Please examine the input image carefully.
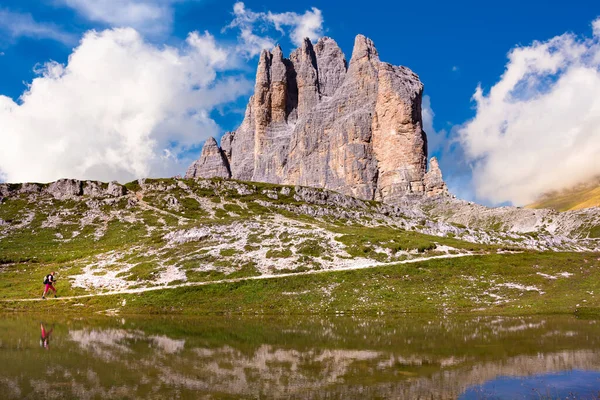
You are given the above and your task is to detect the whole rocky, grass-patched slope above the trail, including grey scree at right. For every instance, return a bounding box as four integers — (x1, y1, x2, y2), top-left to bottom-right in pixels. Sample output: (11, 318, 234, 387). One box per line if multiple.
(0, 178, 600, 295)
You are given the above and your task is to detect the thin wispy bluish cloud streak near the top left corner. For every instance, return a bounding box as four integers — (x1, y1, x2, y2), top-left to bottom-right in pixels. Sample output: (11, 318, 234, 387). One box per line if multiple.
(0, 9, 77, 45)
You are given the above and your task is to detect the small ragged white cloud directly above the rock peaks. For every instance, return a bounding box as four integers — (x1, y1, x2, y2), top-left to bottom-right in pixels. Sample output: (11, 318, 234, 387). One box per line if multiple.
(224, 1, 323, 57)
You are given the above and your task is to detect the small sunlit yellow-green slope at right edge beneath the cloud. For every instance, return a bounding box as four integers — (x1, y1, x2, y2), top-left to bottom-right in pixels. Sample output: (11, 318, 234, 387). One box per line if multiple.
(527, 181, 600, 211)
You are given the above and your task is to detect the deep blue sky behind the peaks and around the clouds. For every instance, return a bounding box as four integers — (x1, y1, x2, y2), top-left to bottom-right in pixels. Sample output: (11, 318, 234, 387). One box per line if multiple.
(0, 0, 600, 204)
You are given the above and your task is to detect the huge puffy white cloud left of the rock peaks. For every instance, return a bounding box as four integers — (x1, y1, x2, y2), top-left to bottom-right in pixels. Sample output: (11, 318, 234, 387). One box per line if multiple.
(0, 28, 252, 182)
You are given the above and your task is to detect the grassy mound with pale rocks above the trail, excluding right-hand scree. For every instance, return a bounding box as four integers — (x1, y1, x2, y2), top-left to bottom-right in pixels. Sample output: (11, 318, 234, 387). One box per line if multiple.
(0, 179, 504, 299)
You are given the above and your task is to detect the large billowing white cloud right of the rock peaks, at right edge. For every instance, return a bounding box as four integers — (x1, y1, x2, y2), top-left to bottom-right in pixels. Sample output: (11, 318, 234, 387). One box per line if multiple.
(458, 19, 600, 205)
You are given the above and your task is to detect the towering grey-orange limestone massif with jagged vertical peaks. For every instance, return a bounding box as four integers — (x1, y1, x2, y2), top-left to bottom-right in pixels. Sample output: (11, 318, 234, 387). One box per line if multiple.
(186, 35, 447, 203)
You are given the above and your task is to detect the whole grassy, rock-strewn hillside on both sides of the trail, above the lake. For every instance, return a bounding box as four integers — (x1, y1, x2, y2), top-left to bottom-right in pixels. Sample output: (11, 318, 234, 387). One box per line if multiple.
(0, 179, 600, 314)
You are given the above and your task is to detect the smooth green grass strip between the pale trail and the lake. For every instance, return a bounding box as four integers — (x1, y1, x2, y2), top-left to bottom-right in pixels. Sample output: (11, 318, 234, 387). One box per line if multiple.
(1, 252, 600, 315)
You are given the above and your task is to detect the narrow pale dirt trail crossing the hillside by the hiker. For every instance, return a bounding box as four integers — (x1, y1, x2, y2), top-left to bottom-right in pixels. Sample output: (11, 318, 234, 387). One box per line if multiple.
(2, 253, 478, 302)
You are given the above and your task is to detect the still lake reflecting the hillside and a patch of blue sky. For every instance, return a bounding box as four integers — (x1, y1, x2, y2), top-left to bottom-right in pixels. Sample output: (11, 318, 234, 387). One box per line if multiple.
(0, 315, 600, 399)
